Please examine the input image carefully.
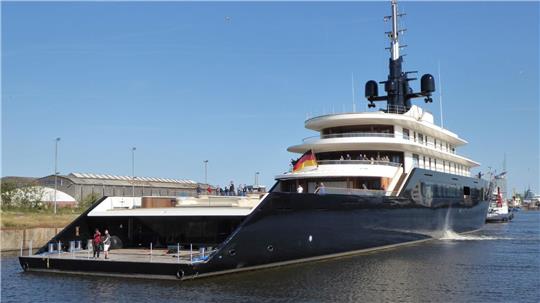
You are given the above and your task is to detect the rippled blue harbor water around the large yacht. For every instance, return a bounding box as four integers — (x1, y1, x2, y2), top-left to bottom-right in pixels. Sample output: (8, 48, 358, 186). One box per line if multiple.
(1, 211, 540, 302)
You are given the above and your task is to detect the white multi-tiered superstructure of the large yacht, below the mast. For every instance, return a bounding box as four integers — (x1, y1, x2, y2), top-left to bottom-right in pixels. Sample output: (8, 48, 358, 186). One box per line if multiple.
(276, 105, 479, 195)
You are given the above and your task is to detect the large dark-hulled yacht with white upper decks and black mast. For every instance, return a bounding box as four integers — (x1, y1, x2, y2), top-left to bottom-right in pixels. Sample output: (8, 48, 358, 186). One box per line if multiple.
(19, 0, 489, 280)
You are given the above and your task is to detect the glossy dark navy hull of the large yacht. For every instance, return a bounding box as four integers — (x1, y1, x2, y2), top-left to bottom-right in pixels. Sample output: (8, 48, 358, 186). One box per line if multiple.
(20, 170, 489, 279)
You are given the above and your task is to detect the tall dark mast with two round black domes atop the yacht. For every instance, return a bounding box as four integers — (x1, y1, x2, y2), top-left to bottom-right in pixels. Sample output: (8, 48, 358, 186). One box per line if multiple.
(365, 0, 435, 114)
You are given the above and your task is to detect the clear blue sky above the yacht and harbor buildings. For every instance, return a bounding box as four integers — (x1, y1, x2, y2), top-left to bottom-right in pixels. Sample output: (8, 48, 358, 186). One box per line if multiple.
(2, 2, 540, 196)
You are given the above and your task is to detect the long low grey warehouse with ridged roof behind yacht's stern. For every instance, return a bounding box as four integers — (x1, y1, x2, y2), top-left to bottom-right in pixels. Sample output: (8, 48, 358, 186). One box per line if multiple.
(37, 173, 198, 201)
